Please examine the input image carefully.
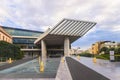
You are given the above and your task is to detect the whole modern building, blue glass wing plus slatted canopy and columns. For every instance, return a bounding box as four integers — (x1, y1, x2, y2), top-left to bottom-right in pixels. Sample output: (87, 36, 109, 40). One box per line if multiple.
(2, 19, 96, 59)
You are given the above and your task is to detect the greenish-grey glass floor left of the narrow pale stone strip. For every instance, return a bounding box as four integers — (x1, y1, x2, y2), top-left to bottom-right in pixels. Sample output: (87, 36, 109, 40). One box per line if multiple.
(0, 58, 60, 80)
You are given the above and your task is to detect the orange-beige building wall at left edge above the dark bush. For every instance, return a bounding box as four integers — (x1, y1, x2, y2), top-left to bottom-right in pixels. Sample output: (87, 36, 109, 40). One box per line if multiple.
(0, 27, 12, 43)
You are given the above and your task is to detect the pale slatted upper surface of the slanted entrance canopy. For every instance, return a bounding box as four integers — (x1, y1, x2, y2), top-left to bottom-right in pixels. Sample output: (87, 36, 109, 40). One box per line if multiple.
(49, 19, 96, 36)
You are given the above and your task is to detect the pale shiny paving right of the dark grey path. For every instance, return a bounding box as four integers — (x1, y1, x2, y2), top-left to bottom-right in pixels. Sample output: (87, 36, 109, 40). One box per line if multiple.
(72, 57, 120, 80)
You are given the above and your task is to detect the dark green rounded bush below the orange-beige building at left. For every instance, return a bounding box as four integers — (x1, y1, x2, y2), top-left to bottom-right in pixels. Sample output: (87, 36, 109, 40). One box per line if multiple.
(0, 41, 24, 60)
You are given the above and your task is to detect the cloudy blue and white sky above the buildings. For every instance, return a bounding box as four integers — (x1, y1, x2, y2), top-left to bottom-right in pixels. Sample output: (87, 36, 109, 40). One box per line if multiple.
(0, 0, 120, 49)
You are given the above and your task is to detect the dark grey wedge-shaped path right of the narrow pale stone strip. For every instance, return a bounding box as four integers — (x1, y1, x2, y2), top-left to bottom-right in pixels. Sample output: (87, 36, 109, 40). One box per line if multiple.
(66, 57, 110, 80)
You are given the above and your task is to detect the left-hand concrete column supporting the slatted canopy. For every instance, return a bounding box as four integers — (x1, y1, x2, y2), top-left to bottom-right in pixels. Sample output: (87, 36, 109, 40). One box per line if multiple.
(41, 40, 47, 62)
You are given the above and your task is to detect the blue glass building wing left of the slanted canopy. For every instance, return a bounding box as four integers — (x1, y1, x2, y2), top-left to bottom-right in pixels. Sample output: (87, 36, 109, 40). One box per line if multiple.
(2, 26, 43, 53)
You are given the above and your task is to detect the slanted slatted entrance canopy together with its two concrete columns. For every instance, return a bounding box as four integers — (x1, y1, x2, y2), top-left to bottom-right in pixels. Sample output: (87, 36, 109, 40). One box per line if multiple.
(34, 19, 96, 61)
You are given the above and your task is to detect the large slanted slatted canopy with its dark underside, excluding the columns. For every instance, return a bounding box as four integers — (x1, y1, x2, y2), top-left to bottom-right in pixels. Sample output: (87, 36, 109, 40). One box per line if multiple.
(34, 19, 96, 45)
